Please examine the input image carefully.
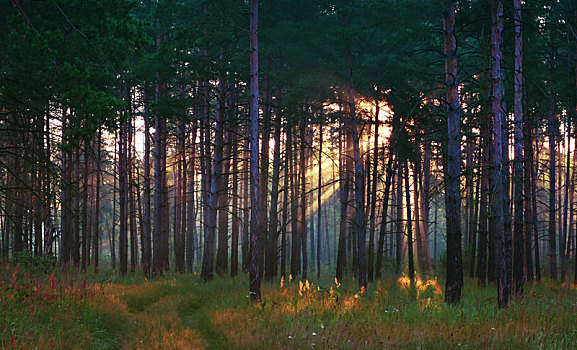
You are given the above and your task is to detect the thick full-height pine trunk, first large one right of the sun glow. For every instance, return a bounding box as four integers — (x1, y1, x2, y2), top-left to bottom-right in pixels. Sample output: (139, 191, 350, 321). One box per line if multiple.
(443, 0, 463, 304)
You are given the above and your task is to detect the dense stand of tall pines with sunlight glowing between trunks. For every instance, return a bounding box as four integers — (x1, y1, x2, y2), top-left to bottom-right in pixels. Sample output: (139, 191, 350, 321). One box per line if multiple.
(0, 0, 577, 306)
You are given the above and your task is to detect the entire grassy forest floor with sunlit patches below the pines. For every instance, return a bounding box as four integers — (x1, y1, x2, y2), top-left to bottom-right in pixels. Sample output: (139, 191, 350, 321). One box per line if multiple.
(0, 263, 577, 349)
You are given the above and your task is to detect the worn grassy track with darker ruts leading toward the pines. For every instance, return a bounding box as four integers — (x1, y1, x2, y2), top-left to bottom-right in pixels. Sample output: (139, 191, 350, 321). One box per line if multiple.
(106, 277, 243, 349)
